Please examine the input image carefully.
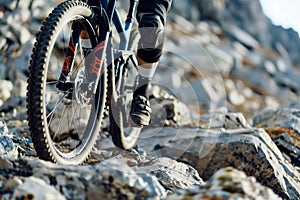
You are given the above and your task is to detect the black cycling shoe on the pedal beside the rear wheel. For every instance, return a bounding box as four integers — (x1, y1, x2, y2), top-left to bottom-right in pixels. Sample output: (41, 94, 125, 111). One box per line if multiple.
(130, 95, 152, 127)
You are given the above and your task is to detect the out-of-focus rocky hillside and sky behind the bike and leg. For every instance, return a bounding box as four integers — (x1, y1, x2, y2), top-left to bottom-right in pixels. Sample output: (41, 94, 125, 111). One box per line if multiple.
(0, 0, 300, 120)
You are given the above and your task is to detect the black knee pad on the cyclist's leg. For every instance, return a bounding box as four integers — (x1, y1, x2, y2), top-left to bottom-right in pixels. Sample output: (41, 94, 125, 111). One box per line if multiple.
(138, 13, 164, 63)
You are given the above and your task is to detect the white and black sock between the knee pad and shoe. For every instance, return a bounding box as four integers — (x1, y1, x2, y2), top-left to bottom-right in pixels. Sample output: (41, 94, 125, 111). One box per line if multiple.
(133, 62, 158, 98)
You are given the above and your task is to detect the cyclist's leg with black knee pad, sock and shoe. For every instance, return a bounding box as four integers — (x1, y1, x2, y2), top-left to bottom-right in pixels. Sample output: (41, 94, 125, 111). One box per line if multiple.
(131, 0, 172, 126)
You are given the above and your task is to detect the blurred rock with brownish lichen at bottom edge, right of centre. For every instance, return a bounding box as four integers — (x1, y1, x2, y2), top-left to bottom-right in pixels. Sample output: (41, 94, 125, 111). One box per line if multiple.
(167, 167, 281, 200)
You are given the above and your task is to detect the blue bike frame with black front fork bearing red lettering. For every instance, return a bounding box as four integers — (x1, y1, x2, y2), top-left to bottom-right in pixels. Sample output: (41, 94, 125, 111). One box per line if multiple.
(57, 0, 139, 94)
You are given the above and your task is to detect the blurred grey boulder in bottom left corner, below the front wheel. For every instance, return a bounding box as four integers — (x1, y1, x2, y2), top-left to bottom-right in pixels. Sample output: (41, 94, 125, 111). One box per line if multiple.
(0, 160, 166, 199)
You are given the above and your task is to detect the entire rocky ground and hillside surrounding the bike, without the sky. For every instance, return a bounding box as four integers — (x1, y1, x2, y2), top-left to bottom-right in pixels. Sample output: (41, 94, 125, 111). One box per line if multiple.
(0, 0, 300, 200)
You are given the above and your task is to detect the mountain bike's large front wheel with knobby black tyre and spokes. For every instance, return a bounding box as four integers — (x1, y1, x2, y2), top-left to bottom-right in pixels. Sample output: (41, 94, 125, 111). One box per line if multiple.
(27, 1, 107, 165)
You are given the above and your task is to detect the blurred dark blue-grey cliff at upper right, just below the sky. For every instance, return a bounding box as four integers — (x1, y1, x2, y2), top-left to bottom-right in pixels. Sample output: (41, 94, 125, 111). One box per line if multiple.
(190, 0, 300, 65)
